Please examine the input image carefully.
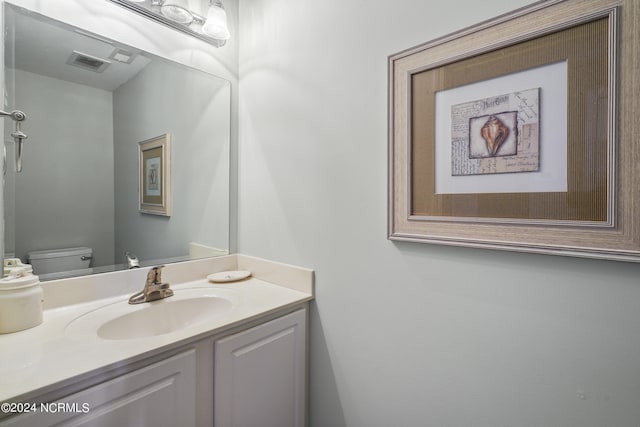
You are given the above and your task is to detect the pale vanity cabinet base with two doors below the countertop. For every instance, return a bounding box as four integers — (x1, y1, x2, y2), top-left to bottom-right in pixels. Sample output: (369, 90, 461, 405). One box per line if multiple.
(0, 305, 307, 427)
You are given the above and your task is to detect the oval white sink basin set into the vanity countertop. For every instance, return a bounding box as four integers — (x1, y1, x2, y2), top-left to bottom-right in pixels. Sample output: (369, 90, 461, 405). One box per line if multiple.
(66, 288, 235, 340)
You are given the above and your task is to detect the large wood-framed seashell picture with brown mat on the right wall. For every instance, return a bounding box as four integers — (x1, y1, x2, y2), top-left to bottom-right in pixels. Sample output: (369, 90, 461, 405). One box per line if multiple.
(388, 0, 640, 261)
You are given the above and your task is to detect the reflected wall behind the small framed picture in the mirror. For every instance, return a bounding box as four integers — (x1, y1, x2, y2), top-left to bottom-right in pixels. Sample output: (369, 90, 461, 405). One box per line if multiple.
(114, 60, 231, 260)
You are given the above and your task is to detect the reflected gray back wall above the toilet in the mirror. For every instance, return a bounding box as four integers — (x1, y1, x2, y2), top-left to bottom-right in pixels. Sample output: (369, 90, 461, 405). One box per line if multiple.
(5, 70, 114, 265)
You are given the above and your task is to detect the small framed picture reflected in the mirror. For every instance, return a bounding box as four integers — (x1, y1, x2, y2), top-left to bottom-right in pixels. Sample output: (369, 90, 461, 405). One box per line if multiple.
(138, 134, 171, 216)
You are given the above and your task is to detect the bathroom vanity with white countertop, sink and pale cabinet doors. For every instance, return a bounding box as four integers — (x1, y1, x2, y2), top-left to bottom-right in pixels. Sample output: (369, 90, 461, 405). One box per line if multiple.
(0, 255, 313, 427)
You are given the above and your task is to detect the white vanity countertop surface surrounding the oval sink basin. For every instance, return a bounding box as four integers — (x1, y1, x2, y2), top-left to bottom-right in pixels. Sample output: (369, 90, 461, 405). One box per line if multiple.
(0, 255, 313, 402)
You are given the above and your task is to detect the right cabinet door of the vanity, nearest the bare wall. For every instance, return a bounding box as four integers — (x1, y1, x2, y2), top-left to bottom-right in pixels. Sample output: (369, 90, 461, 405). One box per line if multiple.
(214, 309, 306, 427)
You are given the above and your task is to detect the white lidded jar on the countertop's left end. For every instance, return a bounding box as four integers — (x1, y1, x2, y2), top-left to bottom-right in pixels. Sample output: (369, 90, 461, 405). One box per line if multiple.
(0, 258, 43, 334)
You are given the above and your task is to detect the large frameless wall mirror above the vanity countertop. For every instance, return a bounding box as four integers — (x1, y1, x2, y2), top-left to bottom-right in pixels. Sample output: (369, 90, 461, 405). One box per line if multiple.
(3, 3, 231, 279)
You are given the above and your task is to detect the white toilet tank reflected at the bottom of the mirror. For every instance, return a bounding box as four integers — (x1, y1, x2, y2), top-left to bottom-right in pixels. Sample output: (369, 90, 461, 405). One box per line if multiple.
(27, 247, 93, 275)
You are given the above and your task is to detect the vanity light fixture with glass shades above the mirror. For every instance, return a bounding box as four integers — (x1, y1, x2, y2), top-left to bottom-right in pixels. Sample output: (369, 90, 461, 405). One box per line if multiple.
(110, 0, 231, 47)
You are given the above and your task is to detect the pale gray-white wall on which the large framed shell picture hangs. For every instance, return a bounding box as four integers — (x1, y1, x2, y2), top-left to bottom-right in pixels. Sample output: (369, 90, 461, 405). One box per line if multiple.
(239, 0, 640, 427)
